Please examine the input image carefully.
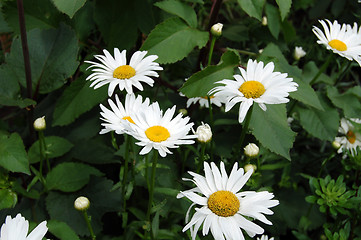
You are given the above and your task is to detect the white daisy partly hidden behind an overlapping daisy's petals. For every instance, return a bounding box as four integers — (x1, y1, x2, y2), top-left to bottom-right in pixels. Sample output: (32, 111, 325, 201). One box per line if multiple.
(100, 94, 149, 134)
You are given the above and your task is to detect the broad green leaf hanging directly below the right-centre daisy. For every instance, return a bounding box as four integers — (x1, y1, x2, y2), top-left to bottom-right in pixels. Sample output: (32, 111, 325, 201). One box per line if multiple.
(250, 104, 296, 160)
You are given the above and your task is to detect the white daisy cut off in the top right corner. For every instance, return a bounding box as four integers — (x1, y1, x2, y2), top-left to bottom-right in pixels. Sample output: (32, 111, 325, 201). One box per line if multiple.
(312, 19, 361, 66)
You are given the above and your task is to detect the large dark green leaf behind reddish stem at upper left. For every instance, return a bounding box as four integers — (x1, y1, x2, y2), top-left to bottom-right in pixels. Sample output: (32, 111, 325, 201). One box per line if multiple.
(6, 24, 79, 93)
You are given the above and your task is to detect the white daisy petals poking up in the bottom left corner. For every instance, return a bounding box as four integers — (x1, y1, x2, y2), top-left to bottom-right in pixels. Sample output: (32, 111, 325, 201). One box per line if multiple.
(0, 213, 48, 240)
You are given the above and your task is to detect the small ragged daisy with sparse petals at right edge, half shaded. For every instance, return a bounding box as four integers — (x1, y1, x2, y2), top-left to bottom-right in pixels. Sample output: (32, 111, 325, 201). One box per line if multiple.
(335, 118, 361, 156)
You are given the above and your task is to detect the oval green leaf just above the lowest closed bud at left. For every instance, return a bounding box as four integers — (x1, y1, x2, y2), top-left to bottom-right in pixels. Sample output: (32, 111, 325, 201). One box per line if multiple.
(46, 162, 103, 192)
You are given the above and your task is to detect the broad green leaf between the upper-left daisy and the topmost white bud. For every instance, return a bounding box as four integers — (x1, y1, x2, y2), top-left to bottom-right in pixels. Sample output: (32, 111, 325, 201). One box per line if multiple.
(141, 18, 209, 63)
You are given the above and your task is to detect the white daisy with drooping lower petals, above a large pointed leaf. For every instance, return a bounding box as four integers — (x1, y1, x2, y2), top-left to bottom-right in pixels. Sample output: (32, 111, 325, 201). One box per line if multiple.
(209, 59, 298, 123)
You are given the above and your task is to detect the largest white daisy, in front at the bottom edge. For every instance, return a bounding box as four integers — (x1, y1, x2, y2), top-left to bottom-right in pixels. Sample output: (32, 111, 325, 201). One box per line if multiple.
(177, 162, 279, 240)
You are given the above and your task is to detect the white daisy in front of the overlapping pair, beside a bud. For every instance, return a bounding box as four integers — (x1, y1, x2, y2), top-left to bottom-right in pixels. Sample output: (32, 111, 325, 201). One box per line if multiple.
(121, 102, 197, 157)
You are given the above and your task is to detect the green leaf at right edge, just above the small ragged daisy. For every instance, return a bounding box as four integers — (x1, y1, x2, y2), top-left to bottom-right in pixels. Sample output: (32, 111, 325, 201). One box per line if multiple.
(327, 86, 361, 118)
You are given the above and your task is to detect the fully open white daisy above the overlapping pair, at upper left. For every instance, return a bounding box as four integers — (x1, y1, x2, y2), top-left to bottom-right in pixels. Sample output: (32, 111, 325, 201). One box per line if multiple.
(85, 48, 163, 96)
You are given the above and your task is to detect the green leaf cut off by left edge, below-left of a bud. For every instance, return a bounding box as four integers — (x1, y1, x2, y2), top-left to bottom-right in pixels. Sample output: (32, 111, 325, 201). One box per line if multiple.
(0, 133, 30, 175)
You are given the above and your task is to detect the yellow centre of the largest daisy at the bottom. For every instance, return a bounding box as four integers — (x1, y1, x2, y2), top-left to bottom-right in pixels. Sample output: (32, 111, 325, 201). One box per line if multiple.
(207, 191, 240, 217)
